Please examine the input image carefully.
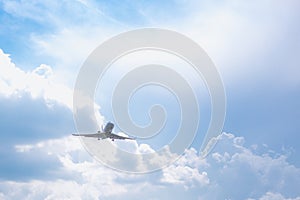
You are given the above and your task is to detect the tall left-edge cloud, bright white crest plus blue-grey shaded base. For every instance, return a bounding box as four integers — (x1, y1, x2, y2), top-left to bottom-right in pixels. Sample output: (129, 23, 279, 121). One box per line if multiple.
(0, 49, 74, 180)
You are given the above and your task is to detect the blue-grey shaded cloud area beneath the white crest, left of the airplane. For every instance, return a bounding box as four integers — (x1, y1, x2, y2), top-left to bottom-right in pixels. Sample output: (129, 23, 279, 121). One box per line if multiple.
(0, 94, 74, 180)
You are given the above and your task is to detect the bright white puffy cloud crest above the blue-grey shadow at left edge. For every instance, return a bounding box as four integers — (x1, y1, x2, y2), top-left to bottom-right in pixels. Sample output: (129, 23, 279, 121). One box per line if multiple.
(0, 49, 73, 109)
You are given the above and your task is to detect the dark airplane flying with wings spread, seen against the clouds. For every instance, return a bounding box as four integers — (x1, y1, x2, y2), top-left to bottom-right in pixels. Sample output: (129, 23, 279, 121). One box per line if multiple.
(72, 122, 135, 141)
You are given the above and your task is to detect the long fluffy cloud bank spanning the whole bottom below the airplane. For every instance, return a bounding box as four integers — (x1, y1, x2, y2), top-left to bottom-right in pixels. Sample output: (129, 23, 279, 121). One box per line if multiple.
(0, 133, 300, 199)
